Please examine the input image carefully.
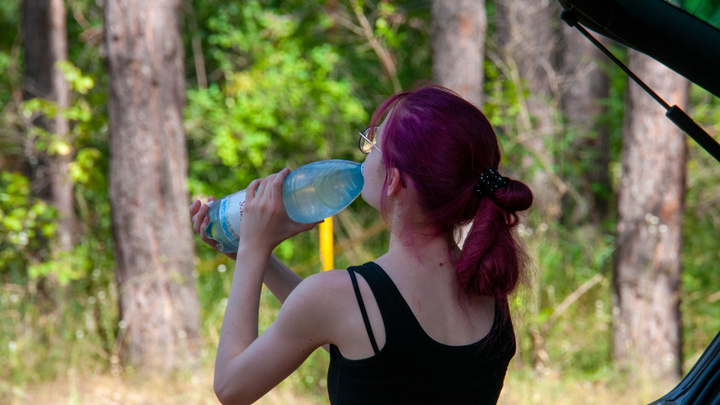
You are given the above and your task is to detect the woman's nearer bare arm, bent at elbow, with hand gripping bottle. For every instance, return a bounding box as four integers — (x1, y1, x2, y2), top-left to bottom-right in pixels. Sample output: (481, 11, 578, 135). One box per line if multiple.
(210, 170, 334, 404)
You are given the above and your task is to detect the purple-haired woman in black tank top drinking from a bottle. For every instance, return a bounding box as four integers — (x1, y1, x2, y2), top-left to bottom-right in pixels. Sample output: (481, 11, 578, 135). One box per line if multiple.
(190, 86, 532, 404)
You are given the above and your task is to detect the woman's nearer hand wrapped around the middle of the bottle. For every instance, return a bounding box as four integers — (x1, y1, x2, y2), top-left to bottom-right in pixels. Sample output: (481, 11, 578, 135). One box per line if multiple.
(240, 169, 322, 254)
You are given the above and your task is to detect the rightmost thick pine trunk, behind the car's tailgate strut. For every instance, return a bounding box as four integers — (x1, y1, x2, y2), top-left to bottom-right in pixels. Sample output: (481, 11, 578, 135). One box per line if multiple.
(613, 50, 689, 380)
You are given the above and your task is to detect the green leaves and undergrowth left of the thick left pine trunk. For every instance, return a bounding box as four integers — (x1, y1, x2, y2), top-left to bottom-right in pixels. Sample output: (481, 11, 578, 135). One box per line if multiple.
(0, 0, 117, 392)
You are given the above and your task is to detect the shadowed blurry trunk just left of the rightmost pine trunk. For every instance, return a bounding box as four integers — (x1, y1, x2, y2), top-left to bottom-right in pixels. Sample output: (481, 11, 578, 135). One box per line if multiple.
(561, 24, 612, 225)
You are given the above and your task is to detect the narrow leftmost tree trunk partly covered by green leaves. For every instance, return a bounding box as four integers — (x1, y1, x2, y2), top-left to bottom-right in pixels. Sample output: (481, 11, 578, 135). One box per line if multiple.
(23, 0, 76, 251)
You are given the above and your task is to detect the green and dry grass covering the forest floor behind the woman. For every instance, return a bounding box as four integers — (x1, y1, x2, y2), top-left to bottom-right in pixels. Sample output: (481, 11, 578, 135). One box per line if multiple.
(0, 202, 720, 405)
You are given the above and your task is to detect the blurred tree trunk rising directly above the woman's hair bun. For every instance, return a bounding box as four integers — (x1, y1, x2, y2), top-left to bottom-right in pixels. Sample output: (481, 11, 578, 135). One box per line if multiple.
(495, 0, 567, 220)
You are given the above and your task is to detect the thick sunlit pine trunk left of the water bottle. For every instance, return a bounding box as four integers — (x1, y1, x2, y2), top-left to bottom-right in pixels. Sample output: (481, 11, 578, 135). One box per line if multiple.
(105, 0, 200, 371)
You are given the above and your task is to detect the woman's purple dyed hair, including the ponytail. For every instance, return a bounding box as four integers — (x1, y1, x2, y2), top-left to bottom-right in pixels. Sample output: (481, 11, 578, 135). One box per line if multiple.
(371, 85, 533, 299)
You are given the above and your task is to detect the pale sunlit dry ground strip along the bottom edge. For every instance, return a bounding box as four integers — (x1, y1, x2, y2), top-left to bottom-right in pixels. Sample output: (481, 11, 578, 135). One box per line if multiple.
(0, 370, 672, 405)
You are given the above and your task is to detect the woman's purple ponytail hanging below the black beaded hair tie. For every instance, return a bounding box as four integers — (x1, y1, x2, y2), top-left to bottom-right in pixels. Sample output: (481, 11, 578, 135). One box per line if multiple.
(456, 180, 533, 298)
